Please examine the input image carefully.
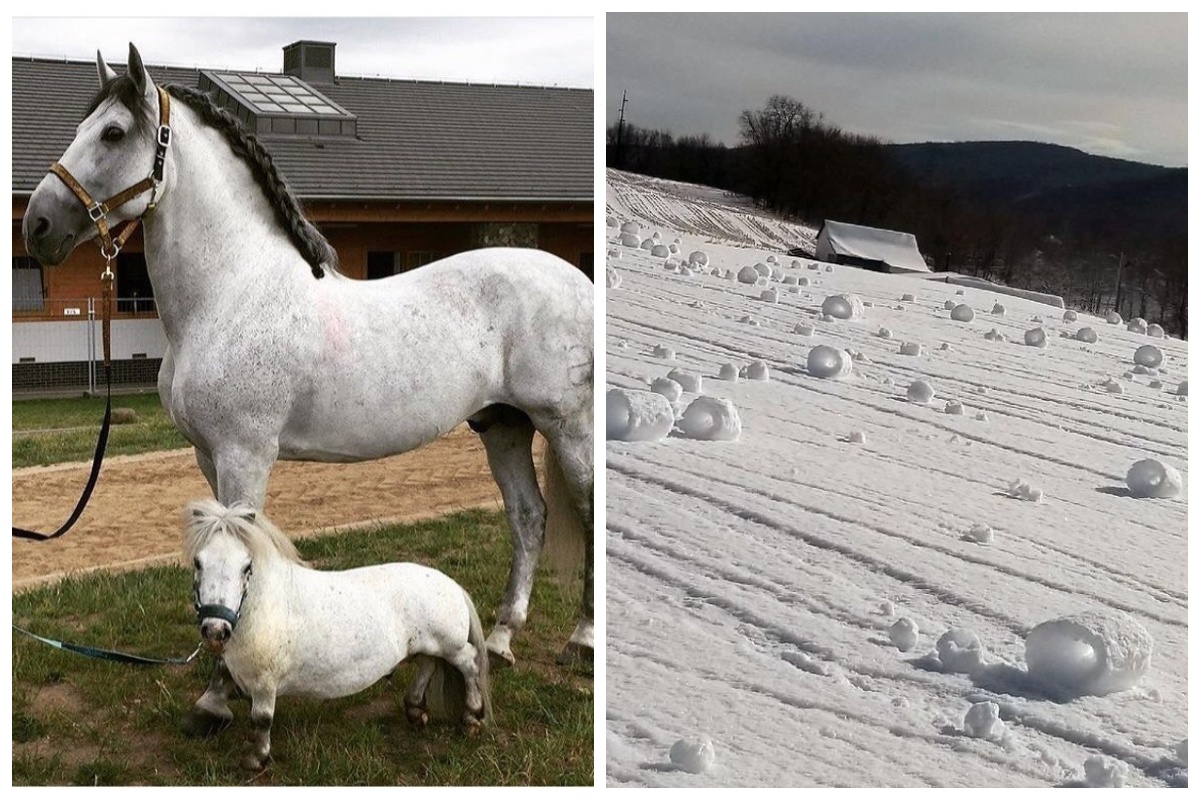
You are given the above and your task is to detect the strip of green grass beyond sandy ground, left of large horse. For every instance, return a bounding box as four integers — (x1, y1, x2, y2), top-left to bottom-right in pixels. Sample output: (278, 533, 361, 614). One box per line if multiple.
(12, 392, 187, 469)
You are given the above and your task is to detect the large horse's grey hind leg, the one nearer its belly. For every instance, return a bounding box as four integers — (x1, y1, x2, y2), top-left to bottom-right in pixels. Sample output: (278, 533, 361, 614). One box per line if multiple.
(470, 405, 546, 667)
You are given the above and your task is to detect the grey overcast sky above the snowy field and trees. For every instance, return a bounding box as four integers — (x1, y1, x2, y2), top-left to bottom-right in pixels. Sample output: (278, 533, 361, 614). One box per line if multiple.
(605, 13, 1188, 167)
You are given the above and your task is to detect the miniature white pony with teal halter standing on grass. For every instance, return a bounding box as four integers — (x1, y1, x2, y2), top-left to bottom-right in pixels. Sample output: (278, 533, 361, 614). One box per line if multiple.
(184, 500, 492, 770)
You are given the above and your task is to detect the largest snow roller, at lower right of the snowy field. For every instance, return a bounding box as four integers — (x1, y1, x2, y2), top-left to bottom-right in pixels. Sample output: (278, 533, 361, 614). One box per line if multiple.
(1025, 612, 1154, 694)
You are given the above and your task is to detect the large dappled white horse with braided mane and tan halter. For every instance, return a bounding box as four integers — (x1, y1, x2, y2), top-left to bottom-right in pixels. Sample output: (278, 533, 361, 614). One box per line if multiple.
(23, 44, 594, 734)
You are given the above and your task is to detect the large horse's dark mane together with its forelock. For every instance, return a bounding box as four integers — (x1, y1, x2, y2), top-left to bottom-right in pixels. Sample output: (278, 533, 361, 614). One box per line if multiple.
(84, 74, 337, 278)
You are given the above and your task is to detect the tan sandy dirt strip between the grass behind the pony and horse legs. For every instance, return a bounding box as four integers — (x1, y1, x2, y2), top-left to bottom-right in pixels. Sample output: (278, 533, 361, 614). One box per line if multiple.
(12, 426, 500, 591)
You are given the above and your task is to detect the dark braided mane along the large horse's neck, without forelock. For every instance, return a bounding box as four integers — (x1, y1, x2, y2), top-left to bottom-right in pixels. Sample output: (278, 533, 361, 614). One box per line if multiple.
(166, 84, 337, 278)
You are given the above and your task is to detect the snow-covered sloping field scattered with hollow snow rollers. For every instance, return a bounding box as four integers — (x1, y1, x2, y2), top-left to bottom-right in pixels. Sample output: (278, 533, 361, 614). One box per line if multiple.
(606, 172, 1188, 787)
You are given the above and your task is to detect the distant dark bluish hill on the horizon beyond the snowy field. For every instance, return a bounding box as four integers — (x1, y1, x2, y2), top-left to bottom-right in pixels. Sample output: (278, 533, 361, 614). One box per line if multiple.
(884, 142, 1188, 244)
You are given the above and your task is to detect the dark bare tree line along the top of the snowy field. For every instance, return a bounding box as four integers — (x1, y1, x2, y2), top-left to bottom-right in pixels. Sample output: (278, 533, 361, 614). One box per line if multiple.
(606, 95, 1187, 337)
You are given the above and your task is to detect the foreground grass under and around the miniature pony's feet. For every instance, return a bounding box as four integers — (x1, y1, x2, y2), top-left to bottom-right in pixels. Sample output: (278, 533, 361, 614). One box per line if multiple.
(12, 511, 594, 786)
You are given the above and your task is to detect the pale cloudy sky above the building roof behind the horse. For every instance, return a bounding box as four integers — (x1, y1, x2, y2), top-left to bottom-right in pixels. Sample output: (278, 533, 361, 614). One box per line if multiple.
(12, 15, 595, 89)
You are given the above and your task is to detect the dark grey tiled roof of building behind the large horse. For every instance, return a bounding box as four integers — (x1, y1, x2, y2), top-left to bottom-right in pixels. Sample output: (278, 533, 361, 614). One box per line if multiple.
(12, 58, 594, 203)
